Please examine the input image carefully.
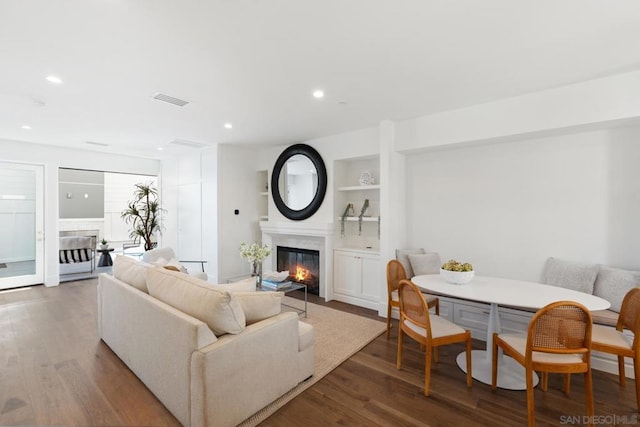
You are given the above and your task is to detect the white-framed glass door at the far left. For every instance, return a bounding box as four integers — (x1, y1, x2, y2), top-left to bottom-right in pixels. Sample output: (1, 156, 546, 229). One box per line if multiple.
(0, 162, 44, 289)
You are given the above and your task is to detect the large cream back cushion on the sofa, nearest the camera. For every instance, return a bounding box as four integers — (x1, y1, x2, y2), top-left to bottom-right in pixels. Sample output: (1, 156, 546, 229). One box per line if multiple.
(147, 268, 246, 335)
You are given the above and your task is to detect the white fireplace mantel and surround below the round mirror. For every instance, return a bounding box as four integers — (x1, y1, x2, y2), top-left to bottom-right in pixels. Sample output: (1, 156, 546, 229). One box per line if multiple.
(260, 221, 334, 301)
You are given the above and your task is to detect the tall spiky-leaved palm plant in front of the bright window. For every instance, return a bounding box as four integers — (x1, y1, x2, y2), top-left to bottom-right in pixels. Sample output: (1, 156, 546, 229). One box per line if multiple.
(120, 183, 164, 251)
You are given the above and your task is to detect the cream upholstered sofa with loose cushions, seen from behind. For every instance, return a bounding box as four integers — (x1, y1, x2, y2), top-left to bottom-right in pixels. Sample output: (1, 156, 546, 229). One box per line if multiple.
(98, 257, 314, 426)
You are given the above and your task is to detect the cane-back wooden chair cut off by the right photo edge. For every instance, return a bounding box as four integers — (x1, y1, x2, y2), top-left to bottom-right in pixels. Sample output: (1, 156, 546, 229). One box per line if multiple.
(591, 288, 640, 412)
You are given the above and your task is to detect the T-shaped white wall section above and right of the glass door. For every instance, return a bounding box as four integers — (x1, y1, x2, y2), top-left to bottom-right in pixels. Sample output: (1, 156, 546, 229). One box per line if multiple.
(0, 140, 160, 286)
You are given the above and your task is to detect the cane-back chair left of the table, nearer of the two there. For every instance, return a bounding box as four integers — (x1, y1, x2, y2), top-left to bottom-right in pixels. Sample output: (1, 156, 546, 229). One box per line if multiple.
(397, 280, 473, 396)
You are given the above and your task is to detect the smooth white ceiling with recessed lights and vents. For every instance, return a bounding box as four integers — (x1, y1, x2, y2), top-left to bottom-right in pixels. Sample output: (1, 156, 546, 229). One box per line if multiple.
(0, 0, 640, 158)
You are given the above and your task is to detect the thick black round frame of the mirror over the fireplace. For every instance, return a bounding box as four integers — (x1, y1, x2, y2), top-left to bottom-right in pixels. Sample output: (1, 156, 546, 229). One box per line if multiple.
(271, 144, 327, 221)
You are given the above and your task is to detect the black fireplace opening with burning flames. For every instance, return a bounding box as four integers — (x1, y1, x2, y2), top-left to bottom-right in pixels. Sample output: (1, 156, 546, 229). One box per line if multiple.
(276, 246, 320, 295)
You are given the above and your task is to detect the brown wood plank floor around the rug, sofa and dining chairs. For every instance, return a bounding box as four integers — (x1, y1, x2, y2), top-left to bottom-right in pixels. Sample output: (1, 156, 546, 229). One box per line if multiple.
(0, 279, 636, 426)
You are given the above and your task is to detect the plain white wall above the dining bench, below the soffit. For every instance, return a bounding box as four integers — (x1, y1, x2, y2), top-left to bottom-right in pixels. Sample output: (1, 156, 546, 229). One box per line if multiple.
(406, 127, 640, 281)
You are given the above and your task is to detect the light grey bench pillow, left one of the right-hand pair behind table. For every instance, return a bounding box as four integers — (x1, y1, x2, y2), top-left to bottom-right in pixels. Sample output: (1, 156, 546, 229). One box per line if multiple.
(544, 257, 600, 294)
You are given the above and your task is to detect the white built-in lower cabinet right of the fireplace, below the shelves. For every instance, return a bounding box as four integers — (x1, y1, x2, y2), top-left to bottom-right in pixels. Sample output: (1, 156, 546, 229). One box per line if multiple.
(333, 249, 381, 310)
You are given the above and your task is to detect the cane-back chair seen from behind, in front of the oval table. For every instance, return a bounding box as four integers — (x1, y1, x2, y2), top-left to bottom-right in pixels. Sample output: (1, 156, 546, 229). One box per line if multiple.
(491, 301, 593, 426)
